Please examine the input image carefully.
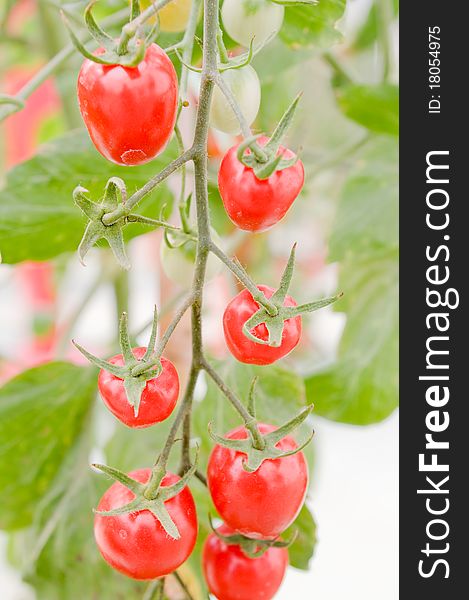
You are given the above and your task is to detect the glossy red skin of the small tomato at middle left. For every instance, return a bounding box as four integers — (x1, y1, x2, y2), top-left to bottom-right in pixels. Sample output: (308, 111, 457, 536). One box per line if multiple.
(98, 348, 179, 428)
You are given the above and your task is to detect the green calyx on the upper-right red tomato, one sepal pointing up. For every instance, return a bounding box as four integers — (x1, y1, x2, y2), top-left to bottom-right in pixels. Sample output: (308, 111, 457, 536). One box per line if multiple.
(237, 93, 302, 180)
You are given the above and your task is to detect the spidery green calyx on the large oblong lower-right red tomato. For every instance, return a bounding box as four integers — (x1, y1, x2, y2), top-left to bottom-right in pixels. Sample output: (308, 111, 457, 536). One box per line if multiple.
(208, 377, 314, 473)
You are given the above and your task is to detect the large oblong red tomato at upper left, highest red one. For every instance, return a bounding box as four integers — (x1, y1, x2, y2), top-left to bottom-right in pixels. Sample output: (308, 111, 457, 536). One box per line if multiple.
(78, 44, 178, 166)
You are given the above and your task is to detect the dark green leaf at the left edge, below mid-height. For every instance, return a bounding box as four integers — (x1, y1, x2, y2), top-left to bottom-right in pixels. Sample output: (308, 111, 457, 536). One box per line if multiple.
(0, 362, 96, 530)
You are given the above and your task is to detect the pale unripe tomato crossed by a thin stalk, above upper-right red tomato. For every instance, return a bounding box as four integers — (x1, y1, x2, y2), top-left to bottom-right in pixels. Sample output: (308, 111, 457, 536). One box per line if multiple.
(210, 65, 261, 135)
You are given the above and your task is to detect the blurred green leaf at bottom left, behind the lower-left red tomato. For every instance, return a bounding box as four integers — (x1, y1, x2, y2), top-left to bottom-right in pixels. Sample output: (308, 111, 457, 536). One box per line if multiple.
(9, 468, 148, 600)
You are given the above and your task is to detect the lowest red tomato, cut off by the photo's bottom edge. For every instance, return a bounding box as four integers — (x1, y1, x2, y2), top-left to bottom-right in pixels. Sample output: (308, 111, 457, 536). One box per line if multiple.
(202, 525, 288, 600)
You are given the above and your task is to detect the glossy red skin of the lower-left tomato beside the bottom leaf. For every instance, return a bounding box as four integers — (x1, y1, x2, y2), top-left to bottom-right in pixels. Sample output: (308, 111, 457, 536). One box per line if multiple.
(94, 469, 197, 579)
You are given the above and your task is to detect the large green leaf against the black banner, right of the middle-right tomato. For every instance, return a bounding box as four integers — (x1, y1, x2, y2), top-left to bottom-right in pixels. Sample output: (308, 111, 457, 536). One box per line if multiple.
(306, 250, 399, 425)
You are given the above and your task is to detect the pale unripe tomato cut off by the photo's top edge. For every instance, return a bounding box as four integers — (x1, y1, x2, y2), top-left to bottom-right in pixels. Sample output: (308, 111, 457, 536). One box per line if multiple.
(221, 0, 285, 48)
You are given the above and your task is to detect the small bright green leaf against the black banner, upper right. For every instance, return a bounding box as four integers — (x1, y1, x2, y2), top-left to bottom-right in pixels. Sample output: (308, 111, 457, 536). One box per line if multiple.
(336, 83, 399, 136)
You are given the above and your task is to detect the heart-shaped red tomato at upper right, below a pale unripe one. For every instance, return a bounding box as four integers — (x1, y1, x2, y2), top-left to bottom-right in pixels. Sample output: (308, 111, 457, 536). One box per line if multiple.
(218, 137, 305, 231)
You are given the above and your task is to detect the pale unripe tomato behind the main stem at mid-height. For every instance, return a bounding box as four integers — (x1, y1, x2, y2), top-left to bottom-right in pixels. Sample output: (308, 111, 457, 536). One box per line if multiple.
(160, 231, 222, 288)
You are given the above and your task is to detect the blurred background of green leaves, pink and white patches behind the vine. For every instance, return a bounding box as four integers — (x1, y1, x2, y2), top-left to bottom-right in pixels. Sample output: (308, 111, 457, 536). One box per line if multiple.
(0, 0, 398, 600)
